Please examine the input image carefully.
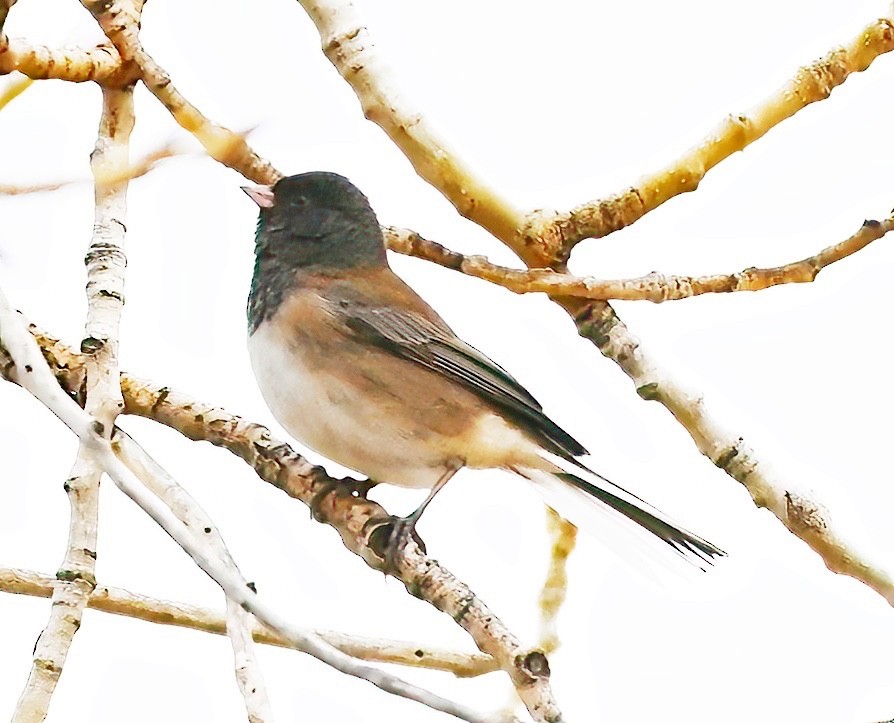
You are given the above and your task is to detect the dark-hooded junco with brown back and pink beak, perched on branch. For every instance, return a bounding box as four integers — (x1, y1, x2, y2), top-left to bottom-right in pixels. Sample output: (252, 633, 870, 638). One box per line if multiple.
(244, 173, 725, 562)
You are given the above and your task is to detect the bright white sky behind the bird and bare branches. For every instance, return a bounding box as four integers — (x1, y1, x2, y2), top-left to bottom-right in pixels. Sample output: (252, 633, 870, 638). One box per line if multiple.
(0, 0, 894, 723)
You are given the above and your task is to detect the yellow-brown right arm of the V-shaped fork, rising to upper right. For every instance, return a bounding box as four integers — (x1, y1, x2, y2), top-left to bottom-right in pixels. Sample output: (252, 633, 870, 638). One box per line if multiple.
(522, 18, 894, 261)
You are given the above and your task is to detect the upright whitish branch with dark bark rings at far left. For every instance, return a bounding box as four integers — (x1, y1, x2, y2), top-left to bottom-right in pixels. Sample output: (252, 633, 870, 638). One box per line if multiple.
(13, 82, 134, 723)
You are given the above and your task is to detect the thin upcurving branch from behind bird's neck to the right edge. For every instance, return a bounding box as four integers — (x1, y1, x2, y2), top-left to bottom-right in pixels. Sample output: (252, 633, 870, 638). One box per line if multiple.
(383, 216, 894, 304)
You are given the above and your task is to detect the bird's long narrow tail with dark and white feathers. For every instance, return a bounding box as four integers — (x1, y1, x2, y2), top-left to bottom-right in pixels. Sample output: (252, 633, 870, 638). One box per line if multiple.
(514, 455, 726, 569)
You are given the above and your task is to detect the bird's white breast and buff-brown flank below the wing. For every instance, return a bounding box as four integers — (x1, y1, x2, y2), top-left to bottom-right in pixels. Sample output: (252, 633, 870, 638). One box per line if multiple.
(248, 296, 458, 487)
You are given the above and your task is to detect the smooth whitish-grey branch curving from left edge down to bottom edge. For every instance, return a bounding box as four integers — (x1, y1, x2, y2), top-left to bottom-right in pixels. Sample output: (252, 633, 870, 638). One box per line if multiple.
(0, 302, 508, 723)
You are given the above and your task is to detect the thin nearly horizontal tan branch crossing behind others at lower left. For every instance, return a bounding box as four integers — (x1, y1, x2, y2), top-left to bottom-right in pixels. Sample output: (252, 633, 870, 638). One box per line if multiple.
(0, 568, 500, 678)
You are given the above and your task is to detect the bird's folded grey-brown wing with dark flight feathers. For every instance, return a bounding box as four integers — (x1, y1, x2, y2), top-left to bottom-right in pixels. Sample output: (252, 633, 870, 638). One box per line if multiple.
(325, 273, 587, 458)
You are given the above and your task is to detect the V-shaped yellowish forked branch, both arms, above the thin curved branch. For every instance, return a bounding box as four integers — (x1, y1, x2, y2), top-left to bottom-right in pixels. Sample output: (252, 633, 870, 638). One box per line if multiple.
(299, 0, 894, 267)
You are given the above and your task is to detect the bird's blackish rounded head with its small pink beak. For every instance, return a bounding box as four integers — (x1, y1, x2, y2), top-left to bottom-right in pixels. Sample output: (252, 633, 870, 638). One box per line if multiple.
(243, 172, 386, 273)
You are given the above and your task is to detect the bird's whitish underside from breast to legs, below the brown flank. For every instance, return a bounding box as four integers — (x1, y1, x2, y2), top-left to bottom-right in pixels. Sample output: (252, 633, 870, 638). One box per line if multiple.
(248, 322, 446, 487)
